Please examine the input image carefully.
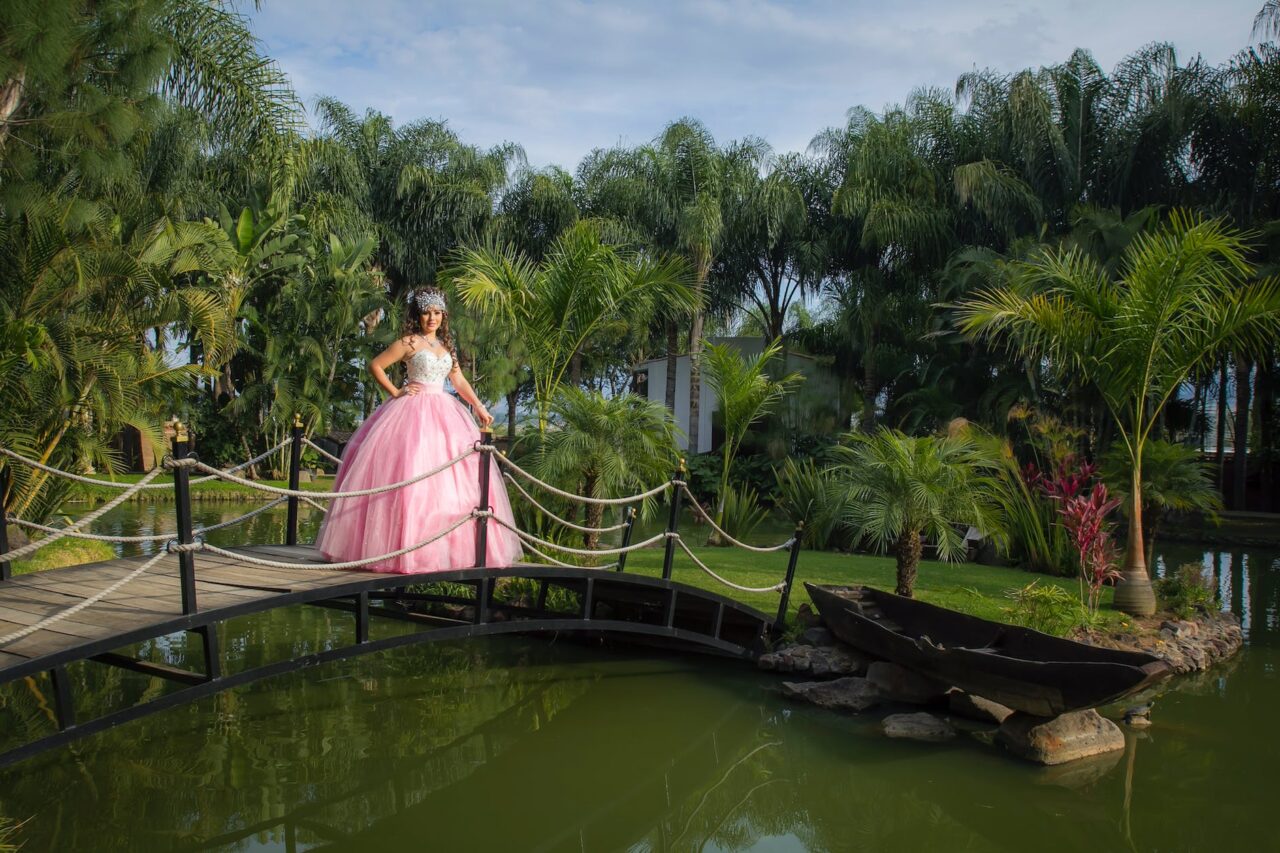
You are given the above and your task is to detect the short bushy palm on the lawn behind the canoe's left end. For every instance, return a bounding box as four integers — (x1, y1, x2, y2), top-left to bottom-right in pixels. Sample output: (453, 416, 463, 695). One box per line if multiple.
(835, 428, 1002, 598)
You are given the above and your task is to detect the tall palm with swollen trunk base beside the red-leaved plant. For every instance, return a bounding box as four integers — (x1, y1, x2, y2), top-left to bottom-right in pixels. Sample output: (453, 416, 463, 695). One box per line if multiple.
(956, 213, 1280, 615)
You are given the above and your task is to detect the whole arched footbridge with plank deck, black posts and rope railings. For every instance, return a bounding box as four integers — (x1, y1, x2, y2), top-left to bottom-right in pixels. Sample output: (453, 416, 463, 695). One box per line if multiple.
(0, 424, 799, 765)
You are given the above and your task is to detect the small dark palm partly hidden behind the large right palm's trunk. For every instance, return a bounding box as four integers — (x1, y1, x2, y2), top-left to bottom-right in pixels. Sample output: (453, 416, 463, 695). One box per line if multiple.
(1102, 441, 1222, 566)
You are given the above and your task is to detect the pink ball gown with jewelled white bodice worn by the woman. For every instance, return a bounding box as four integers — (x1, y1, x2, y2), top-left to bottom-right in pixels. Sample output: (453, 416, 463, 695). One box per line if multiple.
(316, 350, 521, 574)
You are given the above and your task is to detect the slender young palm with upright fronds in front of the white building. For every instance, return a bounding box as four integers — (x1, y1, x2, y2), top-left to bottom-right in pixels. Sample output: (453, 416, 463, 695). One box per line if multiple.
(707, 341, 804, 526)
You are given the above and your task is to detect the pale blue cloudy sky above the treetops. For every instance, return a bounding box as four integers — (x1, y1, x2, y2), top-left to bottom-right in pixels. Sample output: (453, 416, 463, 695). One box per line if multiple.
(248, 0, 1262, 169)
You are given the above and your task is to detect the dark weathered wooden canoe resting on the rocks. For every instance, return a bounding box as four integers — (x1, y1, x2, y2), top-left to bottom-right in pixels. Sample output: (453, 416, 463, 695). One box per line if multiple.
(805, 584, 1171, 717)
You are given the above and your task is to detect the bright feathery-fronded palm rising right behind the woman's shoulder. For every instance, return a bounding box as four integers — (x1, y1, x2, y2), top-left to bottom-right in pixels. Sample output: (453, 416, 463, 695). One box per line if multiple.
(443, 220, 696, 433)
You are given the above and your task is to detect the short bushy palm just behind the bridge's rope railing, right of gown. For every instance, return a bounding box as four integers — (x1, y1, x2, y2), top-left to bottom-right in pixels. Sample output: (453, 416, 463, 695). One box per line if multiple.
(534, 387, 677, 548)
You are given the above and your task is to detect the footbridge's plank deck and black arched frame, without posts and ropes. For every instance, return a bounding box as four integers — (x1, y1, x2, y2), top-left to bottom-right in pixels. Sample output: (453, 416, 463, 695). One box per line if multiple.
(0, 546, 773, 766)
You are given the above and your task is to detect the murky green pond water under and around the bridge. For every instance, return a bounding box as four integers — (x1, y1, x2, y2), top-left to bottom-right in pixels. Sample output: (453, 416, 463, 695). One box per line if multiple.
(0, 503, 1280, 853)
